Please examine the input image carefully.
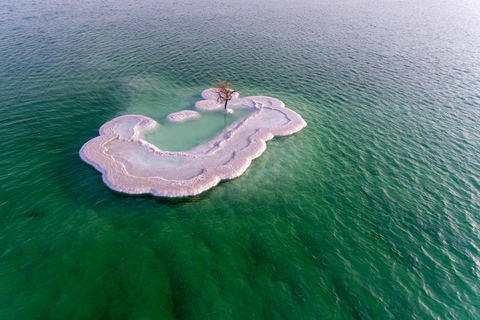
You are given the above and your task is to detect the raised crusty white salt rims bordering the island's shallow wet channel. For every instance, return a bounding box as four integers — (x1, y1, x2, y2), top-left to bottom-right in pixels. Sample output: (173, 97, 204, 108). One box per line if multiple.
(79, 89, 307, 197)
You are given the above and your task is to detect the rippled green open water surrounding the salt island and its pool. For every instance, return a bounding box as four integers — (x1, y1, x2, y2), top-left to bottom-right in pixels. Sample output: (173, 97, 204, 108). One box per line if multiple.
(0, 0, 480, 320)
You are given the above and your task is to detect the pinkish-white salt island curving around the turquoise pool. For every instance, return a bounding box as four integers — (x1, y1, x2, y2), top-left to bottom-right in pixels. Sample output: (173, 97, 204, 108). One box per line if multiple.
(80, 89, 307, 197)
